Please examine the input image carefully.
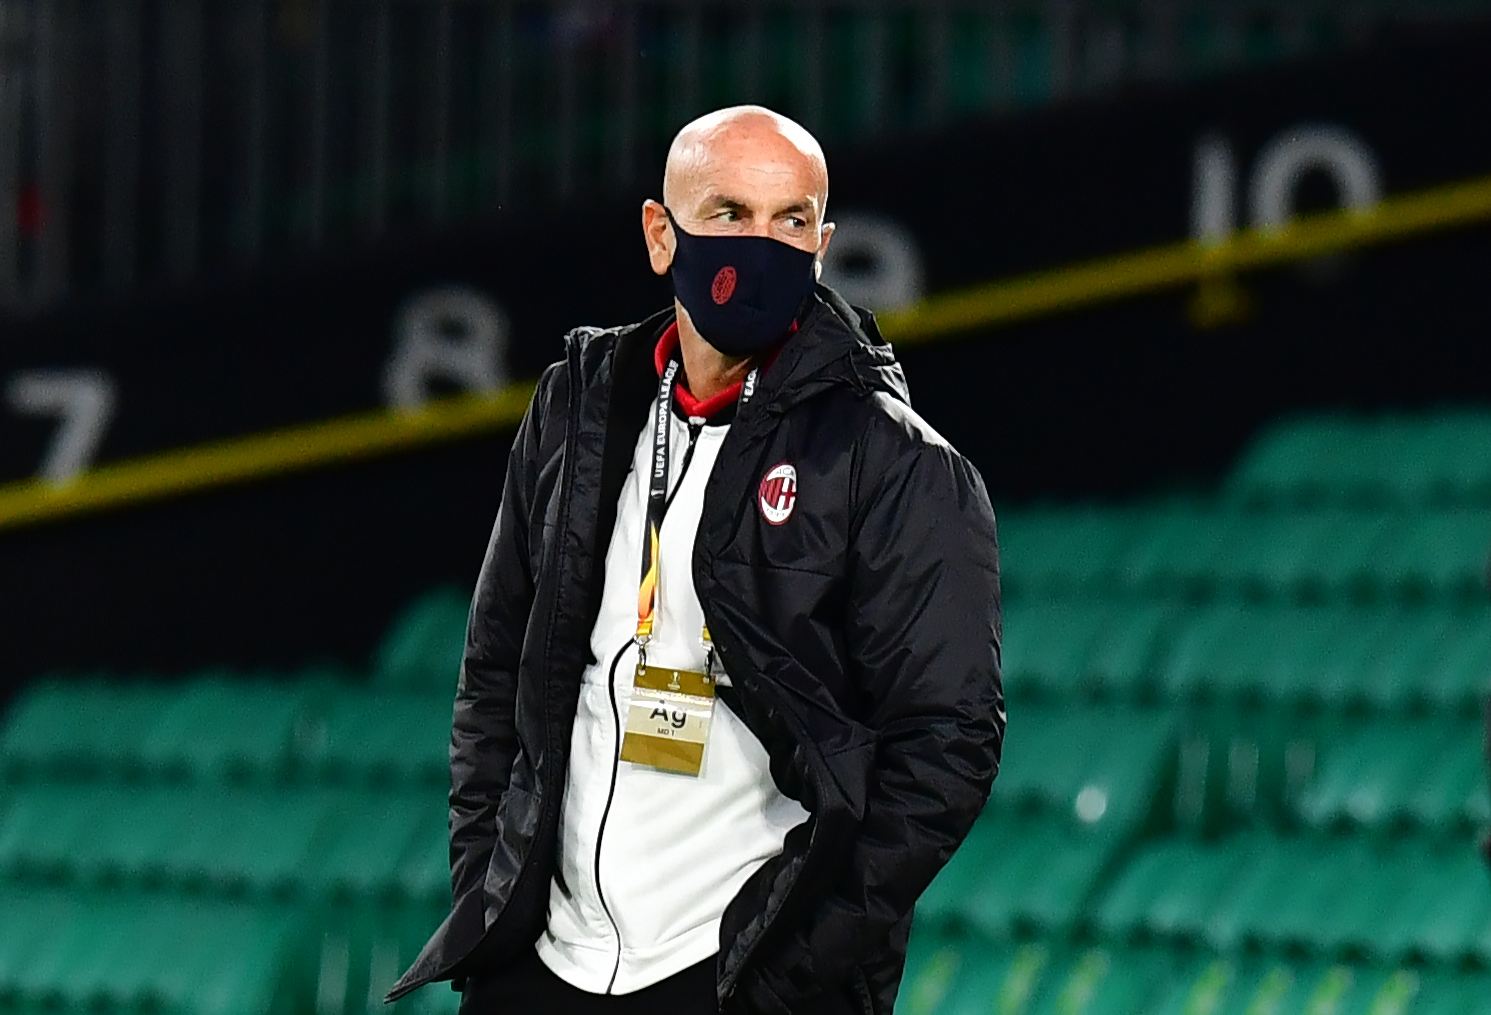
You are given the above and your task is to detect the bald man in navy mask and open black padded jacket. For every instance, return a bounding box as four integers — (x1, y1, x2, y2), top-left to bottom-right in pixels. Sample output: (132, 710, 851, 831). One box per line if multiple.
(389, 107, 1005, 1015)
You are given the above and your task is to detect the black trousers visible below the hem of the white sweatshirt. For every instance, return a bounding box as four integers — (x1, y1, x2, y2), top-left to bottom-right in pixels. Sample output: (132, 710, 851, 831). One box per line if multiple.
(461, 949, 720, 1015)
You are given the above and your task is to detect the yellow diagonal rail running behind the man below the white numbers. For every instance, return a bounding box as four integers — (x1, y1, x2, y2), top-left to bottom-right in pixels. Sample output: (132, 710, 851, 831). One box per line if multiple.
(0, 166, 1491, 529)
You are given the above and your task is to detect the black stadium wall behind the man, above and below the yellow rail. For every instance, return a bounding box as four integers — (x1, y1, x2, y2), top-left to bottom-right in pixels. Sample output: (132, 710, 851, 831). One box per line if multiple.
(0, 21, 1491, 686)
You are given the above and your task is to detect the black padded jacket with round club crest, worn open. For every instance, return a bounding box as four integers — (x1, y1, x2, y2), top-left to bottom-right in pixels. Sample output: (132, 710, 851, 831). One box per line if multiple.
(389, 286, 1005, 1015)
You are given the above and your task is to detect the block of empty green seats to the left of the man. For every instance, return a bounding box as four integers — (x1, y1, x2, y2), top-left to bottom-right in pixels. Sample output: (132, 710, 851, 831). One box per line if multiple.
(0, 611, 464, 1015)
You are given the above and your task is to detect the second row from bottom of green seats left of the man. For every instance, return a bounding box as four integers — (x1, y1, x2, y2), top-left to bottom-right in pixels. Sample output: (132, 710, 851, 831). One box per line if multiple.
(0, 784, 465, 905)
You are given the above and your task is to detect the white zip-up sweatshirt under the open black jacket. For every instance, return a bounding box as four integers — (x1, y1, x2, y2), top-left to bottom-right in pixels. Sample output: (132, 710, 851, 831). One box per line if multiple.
(538, 390, 807, 994)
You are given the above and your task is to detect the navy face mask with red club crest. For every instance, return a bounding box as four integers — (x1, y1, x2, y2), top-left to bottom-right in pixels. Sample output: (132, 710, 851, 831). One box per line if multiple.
(663, 209, 817, 356)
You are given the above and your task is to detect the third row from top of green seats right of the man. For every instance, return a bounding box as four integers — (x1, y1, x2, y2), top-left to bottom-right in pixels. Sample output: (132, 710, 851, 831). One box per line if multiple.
(1003, 598, 1491, 715)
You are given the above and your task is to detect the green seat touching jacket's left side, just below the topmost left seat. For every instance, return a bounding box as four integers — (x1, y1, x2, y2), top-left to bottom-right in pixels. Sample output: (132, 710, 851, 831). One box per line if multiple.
(301, 687, 453, 785)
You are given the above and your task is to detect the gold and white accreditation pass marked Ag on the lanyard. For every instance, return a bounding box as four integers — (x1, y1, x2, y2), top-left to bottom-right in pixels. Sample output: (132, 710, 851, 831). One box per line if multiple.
(622, 666, 714, 775)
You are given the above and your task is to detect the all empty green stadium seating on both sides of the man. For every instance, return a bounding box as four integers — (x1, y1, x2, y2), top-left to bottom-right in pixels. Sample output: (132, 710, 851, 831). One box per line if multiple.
(0, 414, 1491, 1015)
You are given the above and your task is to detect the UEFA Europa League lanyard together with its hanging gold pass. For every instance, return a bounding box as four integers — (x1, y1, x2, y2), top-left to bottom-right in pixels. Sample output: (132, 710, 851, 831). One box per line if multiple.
(622, 359, 759, 775)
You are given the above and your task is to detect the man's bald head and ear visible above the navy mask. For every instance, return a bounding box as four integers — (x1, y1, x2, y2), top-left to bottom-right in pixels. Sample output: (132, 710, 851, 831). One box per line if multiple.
(643, 106, 833, 274)
